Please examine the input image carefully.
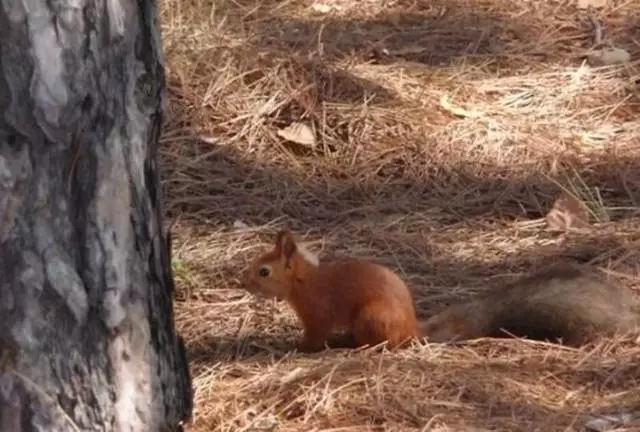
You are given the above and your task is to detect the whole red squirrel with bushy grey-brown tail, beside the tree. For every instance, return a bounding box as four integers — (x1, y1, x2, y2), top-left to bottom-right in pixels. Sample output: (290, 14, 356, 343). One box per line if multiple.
(245, 231, 640, 352)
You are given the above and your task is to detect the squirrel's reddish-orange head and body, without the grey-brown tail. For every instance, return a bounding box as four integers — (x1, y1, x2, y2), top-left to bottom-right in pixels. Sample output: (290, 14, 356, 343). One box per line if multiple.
(246, 231, 419, 351)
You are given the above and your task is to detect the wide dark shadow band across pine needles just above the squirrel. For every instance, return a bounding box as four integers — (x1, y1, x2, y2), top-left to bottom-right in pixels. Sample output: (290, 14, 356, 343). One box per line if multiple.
(164, 139, 640, 231)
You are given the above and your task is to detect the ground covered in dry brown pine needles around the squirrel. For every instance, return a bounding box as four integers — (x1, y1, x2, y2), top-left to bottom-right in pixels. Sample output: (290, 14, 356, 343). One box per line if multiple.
(160, 0, 640, 431)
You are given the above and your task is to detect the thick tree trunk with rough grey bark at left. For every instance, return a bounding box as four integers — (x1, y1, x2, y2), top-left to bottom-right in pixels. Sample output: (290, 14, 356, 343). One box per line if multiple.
(0, 0, 191, 432)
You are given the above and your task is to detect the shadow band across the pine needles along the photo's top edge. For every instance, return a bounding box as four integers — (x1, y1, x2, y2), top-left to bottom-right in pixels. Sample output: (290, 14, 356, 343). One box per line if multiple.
(208, 0, 640, 69)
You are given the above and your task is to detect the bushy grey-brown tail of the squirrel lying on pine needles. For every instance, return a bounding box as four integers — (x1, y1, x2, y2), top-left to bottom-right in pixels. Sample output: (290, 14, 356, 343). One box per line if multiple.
(421, 265, 640, 345)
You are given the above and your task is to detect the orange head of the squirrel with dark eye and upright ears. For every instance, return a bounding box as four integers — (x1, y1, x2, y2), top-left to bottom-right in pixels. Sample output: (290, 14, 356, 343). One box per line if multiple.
(245, 230, 318, 300)
